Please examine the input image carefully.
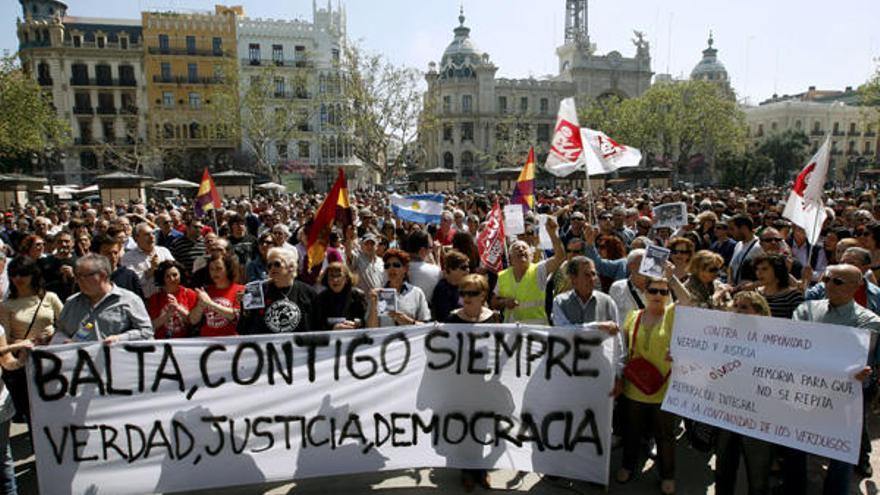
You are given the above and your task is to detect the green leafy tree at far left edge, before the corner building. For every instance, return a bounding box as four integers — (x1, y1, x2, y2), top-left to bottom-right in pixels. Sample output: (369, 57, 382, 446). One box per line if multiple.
(0, 56, 70, 165)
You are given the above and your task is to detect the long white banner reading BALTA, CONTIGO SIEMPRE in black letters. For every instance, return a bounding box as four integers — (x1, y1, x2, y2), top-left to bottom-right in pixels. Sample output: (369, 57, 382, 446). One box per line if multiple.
(28, 324, 617, 495)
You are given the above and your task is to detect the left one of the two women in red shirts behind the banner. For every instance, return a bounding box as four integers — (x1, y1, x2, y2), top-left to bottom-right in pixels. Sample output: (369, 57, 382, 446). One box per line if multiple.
(147, 260, 199, 339)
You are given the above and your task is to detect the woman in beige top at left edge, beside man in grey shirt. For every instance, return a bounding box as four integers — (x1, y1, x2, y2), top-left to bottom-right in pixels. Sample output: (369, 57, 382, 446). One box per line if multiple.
(0, 256, 64, 422)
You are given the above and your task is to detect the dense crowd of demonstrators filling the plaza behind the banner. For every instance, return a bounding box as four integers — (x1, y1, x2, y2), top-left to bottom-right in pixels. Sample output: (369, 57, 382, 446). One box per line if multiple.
(0, 184, 880, 495)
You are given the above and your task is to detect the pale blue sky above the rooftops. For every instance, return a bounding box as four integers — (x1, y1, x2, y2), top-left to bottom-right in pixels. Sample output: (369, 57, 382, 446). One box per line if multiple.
(0, 0, 880, 103)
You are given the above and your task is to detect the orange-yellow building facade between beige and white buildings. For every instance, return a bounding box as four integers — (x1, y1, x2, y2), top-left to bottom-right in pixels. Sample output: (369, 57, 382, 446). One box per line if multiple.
(141, 5, 244, 177)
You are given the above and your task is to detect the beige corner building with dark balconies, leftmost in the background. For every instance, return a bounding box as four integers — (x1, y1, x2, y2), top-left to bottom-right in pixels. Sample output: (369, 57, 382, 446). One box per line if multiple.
(17, 0, 153, 184)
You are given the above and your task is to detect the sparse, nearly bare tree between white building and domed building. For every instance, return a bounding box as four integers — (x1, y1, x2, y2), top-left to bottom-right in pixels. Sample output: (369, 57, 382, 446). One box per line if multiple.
(342, 44, 433, 178)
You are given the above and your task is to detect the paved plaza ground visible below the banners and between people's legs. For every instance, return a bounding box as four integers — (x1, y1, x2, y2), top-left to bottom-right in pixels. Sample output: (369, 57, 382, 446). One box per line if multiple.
(12, 415, 880, 495)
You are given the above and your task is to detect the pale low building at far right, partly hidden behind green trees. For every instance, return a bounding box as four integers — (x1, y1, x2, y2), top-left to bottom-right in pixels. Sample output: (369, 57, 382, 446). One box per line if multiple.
(744, 86, 880, 181)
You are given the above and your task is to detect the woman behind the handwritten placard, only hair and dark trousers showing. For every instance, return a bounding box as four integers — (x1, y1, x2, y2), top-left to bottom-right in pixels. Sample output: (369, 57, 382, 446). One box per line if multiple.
(715, 291, 773, 495)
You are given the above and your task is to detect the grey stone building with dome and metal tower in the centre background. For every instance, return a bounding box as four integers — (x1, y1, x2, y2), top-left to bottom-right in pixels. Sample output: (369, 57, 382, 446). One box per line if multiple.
(419, 0, 652, 185)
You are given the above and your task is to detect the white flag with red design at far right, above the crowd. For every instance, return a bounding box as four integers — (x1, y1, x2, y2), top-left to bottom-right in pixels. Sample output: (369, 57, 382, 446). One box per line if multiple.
(782, 136, 831, 244)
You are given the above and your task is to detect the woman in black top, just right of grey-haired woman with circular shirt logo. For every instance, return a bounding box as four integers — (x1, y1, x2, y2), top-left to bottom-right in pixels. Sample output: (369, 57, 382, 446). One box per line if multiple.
(315, 262, 367, 330)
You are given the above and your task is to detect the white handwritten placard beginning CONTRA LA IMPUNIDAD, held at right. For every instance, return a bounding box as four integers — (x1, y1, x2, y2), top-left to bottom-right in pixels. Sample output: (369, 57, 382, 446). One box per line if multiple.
(663, 307, 869, 464)
